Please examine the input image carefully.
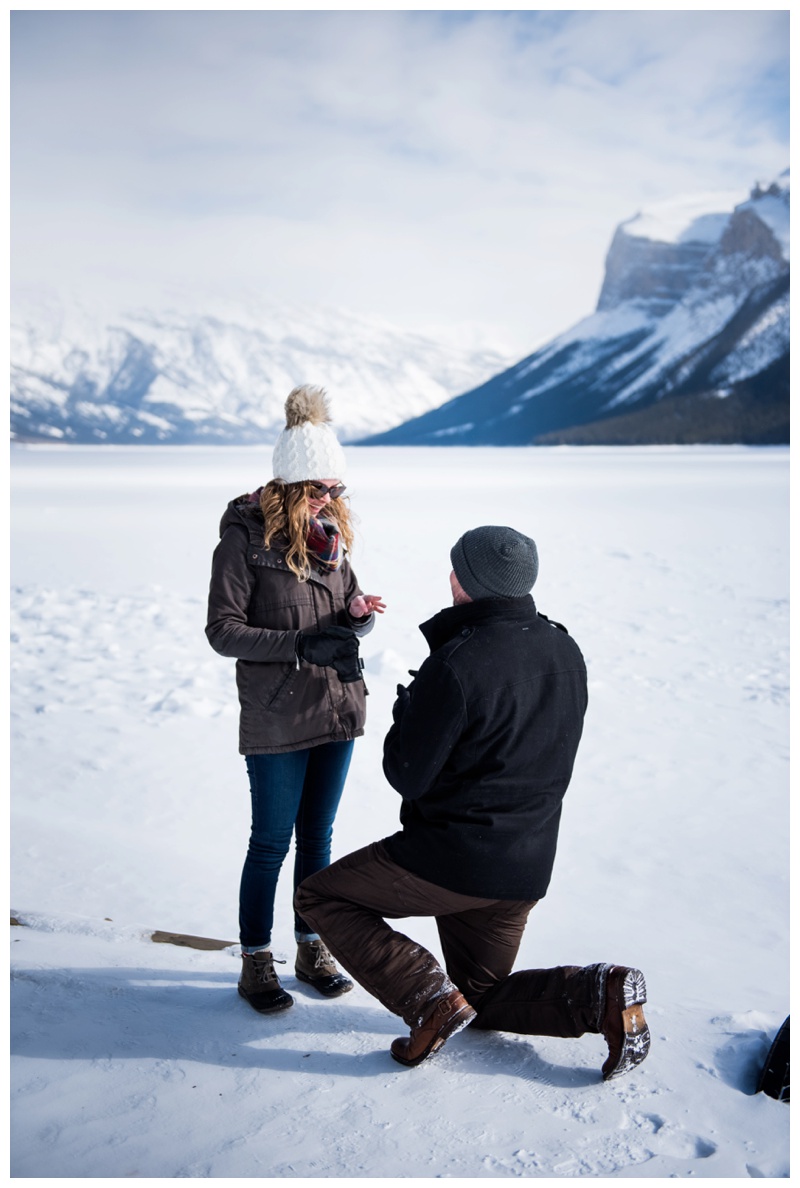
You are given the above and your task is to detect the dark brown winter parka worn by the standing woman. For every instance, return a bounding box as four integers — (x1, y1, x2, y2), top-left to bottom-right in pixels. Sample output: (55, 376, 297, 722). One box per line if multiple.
(206, 495, 374, 754)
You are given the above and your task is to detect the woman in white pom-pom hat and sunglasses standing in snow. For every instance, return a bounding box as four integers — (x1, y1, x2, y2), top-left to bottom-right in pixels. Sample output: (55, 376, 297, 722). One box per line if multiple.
(206, 385, 385, 1013)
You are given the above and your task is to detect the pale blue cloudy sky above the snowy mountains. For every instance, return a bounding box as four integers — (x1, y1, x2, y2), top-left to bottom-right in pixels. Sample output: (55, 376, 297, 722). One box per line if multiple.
(12, 10, 789, 353)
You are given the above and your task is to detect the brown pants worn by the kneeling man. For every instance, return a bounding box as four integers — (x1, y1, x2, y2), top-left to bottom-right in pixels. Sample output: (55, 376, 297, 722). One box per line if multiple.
(295, 841, 601, 1037)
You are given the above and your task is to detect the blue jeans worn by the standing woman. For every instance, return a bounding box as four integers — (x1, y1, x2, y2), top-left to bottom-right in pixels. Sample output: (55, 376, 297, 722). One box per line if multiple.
(239, 739, 353, 952)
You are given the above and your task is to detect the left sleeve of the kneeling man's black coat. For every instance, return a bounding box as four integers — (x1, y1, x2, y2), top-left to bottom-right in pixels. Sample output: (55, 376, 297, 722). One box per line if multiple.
(383, 656, 467, 801)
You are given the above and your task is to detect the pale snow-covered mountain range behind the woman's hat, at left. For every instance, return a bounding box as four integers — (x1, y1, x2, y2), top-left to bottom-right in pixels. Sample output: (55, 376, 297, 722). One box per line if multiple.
(11, 295, 509, 444)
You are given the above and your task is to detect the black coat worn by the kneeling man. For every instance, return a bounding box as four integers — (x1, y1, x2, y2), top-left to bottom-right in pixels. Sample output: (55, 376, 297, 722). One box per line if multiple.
(384, 594, 587, 901)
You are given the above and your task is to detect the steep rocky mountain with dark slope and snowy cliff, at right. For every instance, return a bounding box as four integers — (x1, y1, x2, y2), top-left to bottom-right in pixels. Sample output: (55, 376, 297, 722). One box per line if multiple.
(366, 170, 789, 446)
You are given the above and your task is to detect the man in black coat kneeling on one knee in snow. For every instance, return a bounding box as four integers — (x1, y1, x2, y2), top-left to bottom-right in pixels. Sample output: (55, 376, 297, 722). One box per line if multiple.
(296, 526, 650, 1080)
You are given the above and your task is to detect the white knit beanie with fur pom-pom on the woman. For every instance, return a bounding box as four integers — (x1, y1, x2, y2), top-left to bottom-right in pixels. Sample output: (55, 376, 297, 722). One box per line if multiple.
(272, 384, 347, 482)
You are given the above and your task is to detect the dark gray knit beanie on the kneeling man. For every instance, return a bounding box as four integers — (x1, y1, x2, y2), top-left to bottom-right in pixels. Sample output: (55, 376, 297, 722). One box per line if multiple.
(451, 525, 538, 601)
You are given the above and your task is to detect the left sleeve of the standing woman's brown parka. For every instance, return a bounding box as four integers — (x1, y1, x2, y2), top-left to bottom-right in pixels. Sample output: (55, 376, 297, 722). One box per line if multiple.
(206, 525, 298, 664)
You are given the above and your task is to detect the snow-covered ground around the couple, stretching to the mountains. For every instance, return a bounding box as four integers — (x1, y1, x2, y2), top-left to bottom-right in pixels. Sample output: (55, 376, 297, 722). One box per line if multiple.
(11, 447, 789, 1180)
